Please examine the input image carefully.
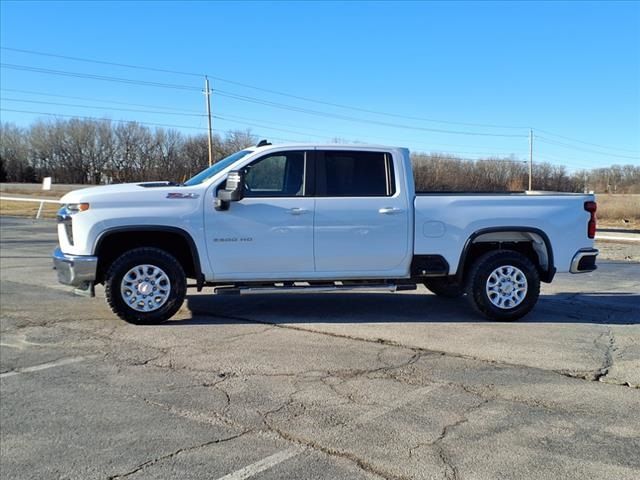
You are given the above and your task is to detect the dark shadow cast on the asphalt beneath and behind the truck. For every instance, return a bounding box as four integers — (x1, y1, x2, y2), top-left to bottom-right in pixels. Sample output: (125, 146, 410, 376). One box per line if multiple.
(171, 292, 640, 325)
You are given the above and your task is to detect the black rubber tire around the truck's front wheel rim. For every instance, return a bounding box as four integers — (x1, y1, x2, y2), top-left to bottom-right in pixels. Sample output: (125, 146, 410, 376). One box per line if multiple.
(104, 247, 187, 325)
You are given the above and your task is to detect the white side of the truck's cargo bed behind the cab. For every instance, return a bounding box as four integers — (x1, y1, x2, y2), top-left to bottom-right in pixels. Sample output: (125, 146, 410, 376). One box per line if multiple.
(414, 192, 595, 274)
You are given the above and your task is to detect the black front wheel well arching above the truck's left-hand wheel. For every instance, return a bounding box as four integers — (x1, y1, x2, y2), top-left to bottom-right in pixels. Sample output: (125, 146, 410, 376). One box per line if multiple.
(94, 229, 201, 283)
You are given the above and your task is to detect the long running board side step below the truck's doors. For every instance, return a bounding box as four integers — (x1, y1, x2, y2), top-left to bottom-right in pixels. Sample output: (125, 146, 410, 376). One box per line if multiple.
(213, 283, 417, 295)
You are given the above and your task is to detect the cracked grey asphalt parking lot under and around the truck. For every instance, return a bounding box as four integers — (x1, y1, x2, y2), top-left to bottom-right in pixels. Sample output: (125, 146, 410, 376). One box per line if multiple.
(0, 217, 640, 480)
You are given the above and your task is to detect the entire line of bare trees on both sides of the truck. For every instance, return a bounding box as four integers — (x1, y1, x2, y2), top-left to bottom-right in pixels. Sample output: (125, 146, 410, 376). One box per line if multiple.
(0, 119, 640, 193)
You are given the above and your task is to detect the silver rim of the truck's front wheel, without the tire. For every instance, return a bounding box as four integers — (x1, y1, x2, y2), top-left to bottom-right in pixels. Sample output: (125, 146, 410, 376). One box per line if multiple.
(120, 264, 171, 312)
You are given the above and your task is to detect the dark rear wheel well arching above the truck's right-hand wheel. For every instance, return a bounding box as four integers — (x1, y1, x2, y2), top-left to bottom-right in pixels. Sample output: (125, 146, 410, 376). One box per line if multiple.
(458, 230, 555, 282)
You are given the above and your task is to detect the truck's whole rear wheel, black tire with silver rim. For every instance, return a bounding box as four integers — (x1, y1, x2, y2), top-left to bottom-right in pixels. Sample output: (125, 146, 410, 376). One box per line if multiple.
(466, 250, 540, 322)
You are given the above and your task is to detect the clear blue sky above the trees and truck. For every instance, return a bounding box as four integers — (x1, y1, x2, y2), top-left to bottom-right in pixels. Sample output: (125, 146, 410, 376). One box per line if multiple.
(0, 0, 640, 171)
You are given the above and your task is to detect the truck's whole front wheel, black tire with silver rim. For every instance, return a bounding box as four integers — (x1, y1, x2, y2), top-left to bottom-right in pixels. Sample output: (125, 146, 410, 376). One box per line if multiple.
(105, 248, 187, 325)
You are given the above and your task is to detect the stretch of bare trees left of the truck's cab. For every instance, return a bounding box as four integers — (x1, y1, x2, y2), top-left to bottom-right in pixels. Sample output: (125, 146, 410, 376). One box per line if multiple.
(0, 119, 256, 185)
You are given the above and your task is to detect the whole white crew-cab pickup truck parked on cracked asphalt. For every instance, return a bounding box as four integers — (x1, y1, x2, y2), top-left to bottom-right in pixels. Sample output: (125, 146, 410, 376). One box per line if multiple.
(53, 141, 598, 324)
